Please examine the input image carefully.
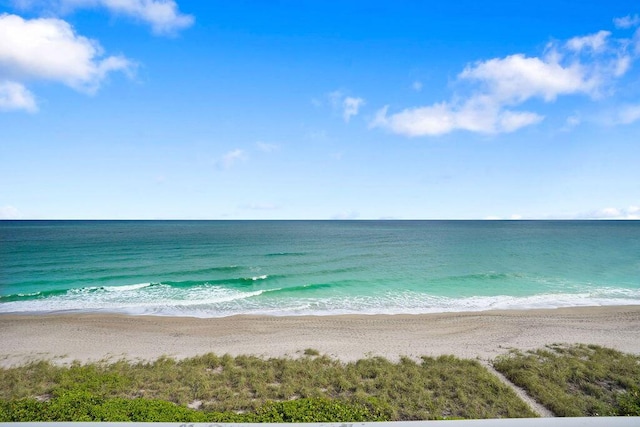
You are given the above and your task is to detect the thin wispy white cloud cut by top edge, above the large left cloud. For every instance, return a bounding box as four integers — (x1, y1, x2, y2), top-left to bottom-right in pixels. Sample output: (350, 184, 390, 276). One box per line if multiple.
(14, 0, 194, 34)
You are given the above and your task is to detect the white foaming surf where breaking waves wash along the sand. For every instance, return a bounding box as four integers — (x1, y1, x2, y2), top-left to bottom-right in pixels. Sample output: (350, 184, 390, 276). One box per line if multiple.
(0, 284, 640, 317)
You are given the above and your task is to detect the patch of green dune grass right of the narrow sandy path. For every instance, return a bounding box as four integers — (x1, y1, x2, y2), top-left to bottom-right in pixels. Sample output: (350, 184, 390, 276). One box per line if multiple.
(494, 344, 640, 417)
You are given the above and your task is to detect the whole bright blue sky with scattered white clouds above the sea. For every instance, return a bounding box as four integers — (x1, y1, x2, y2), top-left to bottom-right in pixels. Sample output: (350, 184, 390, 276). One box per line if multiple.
(0, 0, 640, 219)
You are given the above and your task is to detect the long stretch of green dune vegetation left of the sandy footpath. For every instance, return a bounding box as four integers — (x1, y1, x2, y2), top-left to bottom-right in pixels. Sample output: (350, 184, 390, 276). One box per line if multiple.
(0, 349, 535, 422)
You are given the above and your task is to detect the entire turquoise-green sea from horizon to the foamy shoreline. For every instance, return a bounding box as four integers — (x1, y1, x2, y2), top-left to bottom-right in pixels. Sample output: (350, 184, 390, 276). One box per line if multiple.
(0, 221, 640, 317)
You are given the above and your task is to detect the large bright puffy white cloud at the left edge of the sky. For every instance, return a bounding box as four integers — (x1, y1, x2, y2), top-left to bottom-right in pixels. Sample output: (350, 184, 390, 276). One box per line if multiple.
(0, 14, 134, 94)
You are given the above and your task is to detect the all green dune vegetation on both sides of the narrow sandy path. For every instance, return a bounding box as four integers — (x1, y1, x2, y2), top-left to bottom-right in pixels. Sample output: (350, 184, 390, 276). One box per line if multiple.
(6, 344, 640, 422)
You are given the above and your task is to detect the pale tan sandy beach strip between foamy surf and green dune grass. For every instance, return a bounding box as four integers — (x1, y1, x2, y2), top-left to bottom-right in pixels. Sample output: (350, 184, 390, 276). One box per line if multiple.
(0, 306, 640, 366)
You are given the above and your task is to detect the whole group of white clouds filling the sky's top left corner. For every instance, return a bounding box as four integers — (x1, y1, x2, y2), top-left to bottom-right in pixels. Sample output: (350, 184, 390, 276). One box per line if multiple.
(0, 0, 194, 113)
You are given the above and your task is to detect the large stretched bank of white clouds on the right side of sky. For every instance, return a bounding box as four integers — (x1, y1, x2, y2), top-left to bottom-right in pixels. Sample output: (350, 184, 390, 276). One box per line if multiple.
(370, 23, 640, 137)
